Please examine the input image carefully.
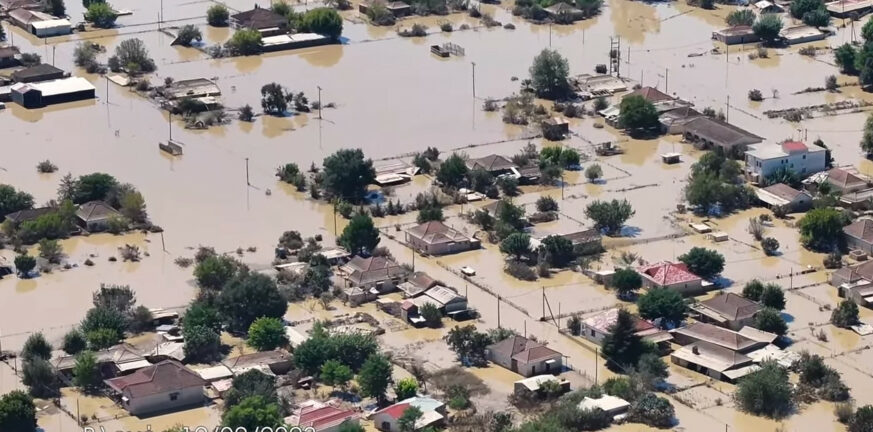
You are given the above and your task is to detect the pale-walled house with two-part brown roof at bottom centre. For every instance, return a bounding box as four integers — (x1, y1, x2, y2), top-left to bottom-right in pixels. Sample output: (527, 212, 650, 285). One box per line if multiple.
(487, 335, 564, 377)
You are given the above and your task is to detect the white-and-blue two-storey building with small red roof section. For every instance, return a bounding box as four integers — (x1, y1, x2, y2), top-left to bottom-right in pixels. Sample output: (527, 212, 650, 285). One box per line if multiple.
(746, 141, 827, 182)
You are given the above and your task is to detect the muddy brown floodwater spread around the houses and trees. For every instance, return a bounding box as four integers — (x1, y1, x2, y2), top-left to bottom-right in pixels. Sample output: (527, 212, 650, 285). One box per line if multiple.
(0, 0, 873, 431)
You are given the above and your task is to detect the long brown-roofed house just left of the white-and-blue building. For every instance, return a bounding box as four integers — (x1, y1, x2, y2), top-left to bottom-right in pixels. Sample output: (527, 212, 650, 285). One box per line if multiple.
(682, 116, 764, 157)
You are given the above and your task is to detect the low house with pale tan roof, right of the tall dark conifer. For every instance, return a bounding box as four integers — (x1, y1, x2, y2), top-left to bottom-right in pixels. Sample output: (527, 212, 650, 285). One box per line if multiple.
(670, 341, 759, 382)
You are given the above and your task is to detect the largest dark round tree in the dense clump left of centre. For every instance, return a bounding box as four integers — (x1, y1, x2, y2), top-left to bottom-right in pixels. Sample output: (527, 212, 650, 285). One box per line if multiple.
(217, 273, 288, 332)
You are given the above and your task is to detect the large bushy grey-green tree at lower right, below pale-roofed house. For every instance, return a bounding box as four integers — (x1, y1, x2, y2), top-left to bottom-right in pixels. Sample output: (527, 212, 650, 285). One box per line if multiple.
(734, 361, 793, 418)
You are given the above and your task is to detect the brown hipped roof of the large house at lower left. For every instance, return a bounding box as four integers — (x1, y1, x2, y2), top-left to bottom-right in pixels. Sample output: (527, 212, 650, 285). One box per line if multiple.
(106, 360, 206, 398)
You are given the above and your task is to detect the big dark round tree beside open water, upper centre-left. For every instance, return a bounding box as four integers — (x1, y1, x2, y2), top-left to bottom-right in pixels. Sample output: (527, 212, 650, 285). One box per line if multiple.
(323, 149, 376, 203)
